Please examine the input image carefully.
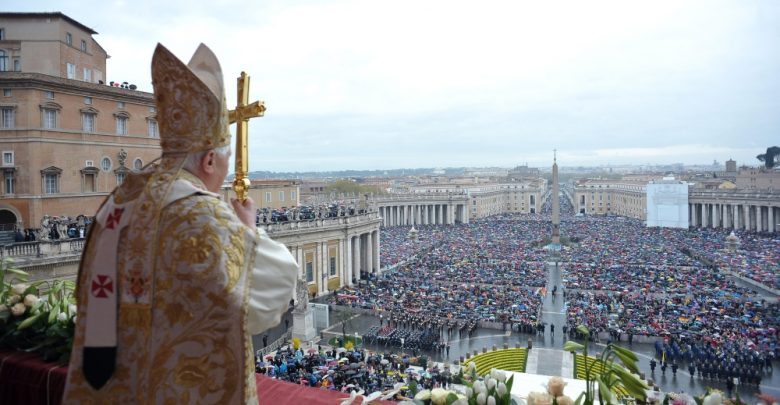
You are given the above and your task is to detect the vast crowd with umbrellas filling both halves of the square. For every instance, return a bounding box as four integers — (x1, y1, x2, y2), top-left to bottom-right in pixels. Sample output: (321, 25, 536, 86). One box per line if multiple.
(266, 192, 780, 394)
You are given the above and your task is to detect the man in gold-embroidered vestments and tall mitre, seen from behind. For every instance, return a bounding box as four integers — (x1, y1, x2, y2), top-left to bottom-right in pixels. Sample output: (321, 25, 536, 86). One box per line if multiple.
(63, 45, 298, 404)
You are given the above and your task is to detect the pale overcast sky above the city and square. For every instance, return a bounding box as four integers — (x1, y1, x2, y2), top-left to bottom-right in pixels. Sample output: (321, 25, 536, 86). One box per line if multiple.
(10, 0, 780, 171)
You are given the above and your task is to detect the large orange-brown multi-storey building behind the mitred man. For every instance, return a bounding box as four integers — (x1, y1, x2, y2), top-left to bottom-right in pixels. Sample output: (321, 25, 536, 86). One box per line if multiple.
(0, 12, 160, 229)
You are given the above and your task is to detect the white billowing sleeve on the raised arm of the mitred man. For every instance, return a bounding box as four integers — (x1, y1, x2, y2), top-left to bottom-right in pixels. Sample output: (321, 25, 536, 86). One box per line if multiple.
(247, 229, 298, 335)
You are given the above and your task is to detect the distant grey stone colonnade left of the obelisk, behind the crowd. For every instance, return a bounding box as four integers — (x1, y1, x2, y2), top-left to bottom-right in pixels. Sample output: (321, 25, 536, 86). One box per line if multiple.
(379, 203, 469, 226)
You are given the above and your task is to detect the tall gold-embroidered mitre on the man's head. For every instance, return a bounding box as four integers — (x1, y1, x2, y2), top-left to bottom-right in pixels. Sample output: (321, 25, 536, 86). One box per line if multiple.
(152, 44, 230, 153)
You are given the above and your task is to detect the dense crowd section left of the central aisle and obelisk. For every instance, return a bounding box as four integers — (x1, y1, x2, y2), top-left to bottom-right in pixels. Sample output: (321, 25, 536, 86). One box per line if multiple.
(332, 220, 547, 340)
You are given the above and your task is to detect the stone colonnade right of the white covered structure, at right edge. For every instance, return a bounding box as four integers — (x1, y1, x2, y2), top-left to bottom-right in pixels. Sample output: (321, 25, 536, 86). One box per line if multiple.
(688, 203, 780, 232)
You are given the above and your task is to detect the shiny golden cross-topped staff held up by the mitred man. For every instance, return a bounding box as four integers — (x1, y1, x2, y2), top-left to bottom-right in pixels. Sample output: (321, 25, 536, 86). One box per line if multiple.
(228, 72, 265, 201)
